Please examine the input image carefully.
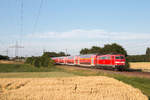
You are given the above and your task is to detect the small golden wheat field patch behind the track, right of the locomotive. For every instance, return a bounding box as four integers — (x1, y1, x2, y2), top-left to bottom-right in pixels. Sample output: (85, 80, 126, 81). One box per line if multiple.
(130, 62, 150, 70)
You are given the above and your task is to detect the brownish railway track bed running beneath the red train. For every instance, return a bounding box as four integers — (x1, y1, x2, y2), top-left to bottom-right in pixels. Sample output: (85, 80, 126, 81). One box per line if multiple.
(59, 65, 150, 79)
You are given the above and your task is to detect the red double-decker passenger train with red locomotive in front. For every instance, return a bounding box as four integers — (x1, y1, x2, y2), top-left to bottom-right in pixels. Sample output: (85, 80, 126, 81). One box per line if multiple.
(52, 54, 126, 70)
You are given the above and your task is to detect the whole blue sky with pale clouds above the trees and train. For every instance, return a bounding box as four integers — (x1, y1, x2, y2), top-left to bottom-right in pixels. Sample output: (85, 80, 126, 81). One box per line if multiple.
(0, 0, 150, 56)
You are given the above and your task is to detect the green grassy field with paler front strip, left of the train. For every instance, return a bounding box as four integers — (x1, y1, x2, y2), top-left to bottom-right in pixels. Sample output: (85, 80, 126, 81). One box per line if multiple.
(0, 64, 75, 78)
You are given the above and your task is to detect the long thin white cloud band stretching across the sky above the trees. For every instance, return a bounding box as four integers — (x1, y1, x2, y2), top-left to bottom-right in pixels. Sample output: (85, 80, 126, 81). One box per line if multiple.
(27, 29, 150, 40)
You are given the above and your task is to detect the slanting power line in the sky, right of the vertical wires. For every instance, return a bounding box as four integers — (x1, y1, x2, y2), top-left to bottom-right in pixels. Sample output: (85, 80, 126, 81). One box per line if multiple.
(33, 0, 44, 33)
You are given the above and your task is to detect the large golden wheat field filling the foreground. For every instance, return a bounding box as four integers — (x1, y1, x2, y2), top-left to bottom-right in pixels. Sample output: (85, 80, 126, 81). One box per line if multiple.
(0, 76, 148, 100)
